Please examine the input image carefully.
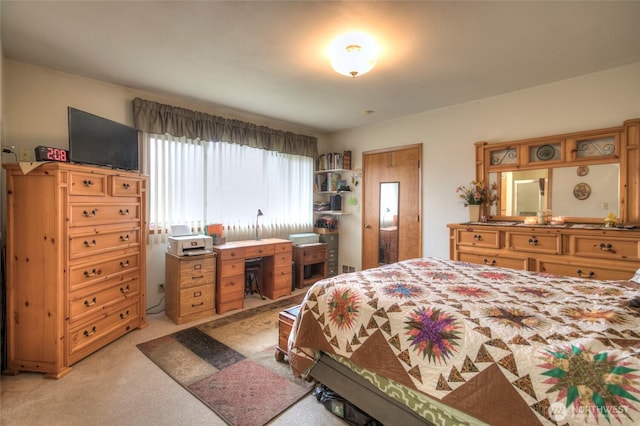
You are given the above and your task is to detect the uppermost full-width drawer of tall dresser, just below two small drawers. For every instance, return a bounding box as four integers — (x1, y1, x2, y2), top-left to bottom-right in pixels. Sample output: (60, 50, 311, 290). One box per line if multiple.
(69, 203, 140, 227)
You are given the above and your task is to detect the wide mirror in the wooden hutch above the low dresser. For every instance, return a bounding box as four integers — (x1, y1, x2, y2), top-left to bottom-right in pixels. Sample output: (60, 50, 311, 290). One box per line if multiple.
(489, 163, 620, 218)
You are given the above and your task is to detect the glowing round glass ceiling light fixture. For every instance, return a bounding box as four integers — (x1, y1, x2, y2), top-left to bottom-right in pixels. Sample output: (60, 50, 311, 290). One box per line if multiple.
(329, 32, 379, 78)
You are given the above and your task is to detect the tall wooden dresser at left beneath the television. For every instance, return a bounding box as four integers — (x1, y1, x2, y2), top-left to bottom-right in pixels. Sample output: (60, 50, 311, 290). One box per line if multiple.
(4, 163, 147, 378)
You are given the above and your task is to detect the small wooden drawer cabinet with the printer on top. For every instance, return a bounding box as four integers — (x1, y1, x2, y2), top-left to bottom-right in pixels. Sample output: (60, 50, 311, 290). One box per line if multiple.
(165, 253, 216, 324)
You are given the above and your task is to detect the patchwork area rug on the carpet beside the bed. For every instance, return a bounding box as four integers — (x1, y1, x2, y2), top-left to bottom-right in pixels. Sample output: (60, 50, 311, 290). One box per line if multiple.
(138, 295, 313, 426)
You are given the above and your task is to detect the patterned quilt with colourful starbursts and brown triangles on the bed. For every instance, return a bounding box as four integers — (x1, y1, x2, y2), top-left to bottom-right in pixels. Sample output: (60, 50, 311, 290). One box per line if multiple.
(289, 258, 640, 425)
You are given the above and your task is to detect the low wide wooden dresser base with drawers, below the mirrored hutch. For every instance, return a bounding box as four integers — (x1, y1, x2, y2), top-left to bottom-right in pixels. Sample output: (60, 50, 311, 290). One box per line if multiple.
(448, 224, 640, 280)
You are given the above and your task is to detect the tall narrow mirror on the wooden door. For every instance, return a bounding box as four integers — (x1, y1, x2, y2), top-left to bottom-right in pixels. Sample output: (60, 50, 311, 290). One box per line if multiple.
(378, 182, 400, 265)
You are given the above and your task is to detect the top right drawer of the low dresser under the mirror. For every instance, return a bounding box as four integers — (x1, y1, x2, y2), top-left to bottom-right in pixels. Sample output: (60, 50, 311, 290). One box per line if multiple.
(569, 235, 640, 262)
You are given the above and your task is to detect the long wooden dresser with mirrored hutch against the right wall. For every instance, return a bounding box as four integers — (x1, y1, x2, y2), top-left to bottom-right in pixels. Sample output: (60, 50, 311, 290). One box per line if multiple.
(448, 119, 640, 280)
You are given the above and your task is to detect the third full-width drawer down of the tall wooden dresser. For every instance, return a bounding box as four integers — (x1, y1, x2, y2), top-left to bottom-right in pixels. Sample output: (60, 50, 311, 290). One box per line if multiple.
(69, 253, 140, 291)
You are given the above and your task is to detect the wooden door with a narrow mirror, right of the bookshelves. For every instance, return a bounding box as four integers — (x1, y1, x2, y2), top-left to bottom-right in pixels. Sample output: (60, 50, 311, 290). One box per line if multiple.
(362, 144, 422, 269)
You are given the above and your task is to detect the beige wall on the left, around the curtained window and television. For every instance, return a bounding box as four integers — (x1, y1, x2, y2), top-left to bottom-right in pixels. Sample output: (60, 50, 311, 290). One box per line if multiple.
(1, 59, 327, 307)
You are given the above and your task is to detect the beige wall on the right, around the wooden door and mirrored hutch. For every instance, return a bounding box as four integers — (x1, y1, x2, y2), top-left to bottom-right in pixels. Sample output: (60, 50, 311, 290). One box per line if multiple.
(330, 63, 640, 268)
